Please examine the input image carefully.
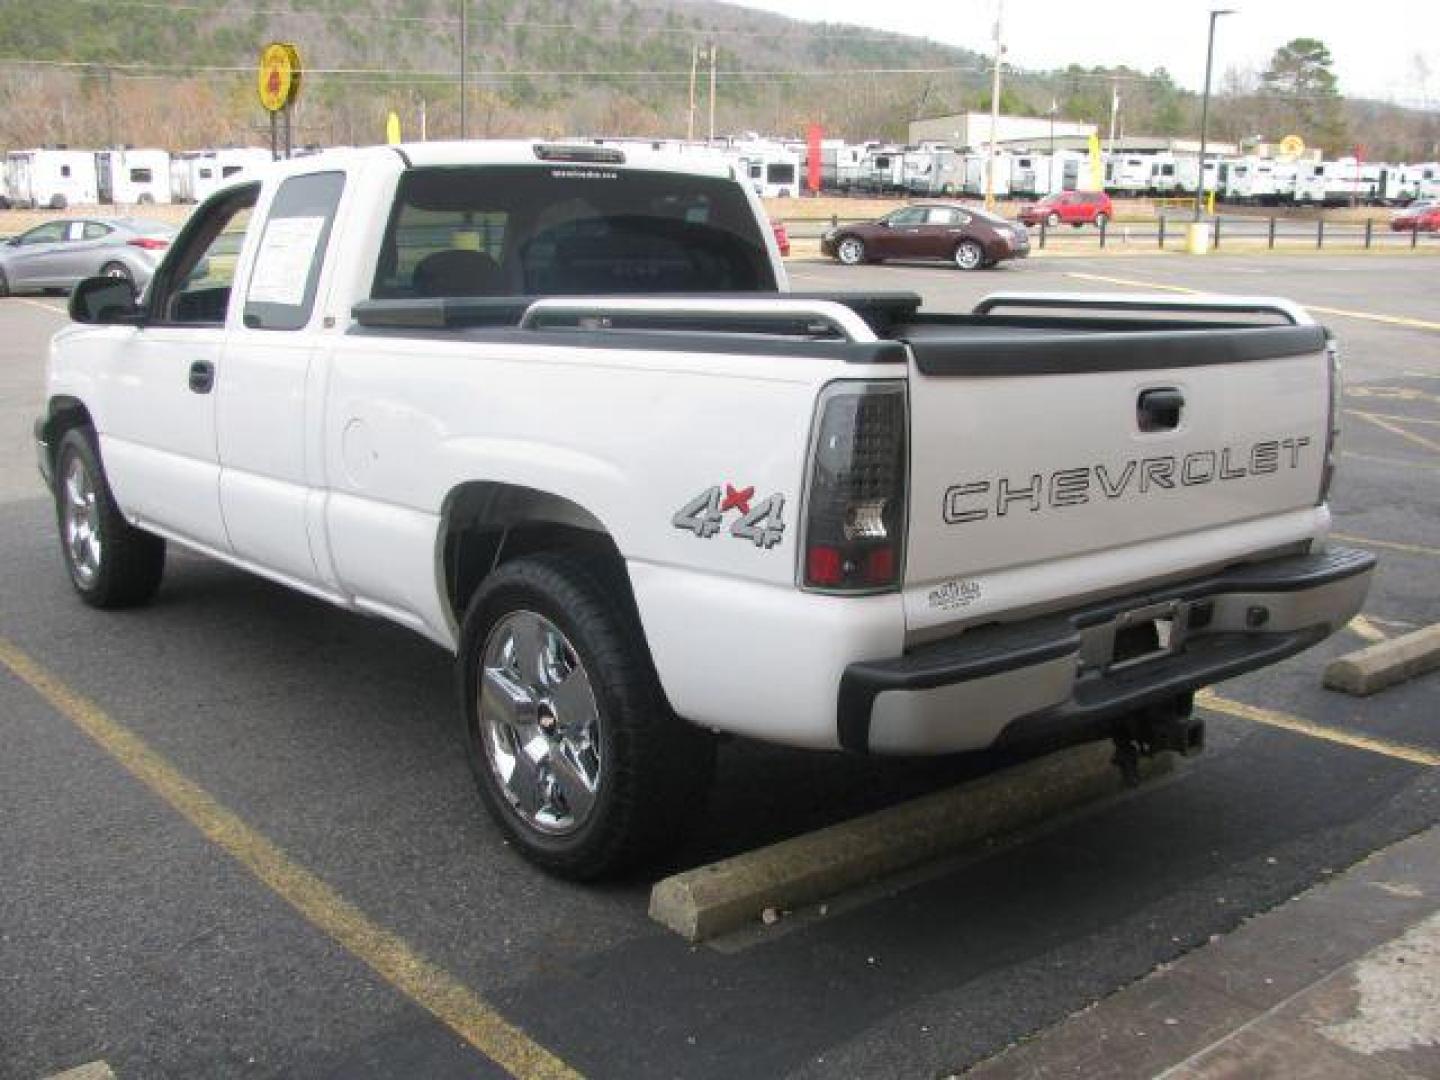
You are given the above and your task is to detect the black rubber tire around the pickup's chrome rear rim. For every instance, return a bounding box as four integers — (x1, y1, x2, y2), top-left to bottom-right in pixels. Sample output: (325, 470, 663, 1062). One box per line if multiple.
(456, 554, 714, 881)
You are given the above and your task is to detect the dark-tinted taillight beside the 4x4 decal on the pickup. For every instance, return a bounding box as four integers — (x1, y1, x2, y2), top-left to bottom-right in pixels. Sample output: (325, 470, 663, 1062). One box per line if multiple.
(801, 382, 909, 593)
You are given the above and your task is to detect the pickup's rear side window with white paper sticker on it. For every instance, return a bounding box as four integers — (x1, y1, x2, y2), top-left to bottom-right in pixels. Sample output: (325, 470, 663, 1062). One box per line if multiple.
(245, 173, 346, 330)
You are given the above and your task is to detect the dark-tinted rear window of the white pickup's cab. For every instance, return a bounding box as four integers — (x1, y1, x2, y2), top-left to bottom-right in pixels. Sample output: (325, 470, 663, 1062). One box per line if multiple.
(372, 164, 776, 298)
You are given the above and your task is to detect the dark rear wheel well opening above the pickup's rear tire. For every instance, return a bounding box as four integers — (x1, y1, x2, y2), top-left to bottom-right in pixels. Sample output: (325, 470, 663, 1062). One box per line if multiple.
(441, 482, 634, 626)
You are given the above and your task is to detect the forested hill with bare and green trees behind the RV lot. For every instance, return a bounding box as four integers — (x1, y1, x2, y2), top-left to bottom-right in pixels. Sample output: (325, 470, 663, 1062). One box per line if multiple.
(0, 0, 1440, 160)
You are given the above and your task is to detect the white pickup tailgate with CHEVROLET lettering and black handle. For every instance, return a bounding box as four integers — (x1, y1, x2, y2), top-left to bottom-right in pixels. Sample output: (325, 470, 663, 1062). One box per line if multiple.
(904, 325, 1331, 634)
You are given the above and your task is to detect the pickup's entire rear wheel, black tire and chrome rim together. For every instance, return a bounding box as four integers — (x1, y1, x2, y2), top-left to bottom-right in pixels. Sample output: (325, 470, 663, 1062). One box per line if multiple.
(459, 554, 714, 880)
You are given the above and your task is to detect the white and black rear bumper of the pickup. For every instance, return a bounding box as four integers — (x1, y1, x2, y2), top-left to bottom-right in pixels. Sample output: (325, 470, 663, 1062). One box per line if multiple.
(837, 549, 1375, 755)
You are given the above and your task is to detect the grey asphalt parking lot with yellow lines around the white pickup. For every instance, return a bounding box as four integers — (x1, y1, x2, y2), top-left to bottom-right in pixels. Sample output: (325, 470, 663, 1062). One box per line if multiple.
(0, 255, 1440, 1079)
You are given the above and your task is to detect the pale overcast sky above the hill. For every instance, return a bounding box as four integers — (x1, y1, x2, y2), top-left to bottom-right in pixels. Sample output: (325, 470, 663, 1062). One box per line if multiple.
(739, 0, 1440, 107)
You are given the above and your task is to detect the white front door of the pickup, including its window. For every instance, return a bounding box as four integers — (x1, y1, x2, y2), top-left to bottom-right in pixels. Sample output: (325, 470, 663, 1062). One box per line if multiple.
(96, 184, 259, 552)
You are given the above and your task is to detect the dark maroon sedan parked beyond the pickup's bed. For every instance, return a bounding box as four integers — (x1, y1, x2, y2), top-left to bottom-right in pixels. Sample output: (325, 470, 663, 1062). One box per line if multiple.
(819, 203, 1030, 271)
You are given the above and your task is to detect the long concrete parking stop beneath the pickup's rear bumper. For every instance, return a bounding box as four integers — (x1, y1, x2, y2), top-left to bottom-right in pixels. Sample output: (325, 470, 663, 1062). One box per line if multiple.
(649, 743, 1174, 942)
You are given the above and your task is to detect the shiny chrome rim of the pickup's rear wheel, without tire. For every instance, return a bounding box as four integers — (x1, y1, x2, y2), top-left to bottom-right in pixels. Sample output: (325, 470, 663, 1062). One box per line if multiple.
(478, 611, 602, 835)
